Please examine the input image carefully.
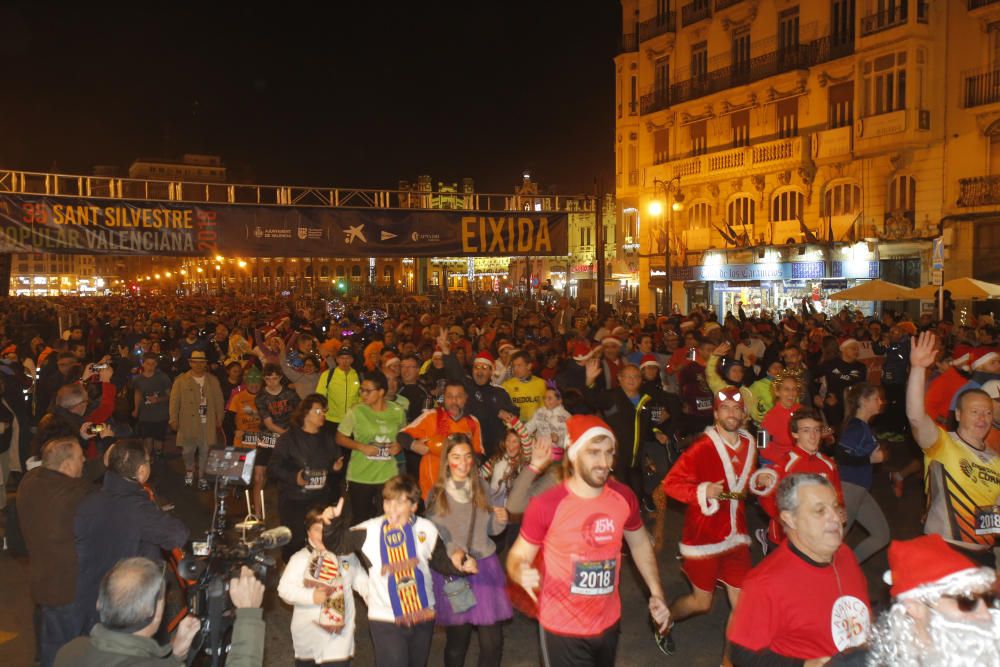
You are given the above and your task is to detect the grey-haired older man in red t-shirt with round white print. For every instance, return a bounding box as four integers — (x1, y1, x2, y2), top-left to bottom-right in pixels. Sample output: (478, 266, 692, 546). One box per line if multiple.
(727, 473, 871, 667)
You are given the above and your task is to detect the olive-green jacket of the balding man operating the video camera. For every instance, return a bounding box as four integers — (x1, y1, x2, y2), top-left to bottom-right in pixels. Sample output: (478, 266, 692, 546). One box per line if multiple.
(55, 608, 264, 667)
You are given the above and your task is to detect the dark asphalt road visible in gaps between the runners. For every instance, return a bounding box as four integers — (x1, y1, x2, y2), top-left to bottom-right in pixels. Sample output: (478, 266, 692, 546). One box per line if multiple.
(0, 438, 924, 667)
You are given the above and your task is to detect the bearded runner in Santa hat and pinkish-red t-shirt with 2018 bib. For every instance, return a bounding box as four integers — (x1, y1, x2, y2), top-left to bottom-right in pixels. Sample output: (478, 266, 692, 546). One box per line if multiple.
(507, 415, 670, 667)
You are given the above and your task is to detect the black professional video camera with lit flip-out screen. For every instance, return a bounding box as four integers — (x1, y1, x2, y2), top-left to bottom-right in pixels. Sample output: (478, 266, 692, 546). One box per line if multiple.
(177, 447, 292, 666)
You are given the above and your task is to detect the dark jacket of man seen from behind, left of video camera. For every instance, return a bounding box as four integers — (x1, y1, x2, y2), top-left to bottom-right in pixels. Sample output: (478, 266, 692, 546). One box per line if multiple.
(73, 470, 188, 631)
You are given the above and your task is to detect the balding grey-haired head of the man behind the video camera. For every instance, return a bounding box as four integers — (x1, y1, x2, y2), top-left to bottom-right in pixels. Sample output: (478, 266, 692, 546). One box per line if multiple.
(97, 558, 164, 632)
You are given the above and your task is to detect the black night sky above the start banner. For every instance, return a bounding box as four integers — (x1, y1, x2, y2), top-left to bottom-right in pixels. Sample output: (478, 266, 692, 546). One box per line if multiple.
(0, 0, 621, 194)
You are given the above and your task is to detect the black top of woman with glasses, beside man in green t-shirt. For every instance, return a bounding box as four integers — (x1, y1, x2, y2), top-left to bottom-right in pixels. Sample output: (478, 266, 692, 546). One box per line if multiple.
(267, 424, 341, 502)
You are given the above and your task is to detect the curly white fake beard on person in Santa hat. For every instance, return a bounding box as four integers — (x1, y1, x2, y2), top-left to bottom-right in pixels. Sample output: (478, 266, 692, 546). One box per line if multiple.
(869, 603, 1000, 667)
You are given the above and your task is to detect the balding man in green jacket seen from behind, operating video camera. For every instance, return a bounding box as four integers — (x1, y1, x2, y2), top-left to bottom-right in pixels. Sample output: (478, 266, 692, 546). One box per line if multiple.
(55, 558, 264, 667)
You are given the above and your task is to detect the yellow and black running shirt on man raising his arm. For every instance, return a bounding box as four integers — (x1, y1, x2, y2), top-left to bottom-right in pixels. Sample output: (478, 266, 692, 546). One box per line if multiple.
(924, 427, 1000, 548)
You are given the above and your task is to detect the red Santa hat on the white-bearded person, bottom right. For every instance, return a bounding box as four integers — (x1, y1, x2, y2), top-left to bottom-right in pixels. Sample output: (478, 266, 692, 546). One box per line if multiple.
(883, 534, 996, 602)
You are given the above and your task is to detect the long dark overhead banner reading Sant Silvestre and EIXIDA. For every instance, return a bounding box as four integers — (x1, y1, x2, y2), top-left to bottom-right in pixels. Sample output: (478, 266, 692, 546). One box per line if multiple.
(0, 195, 569, 257)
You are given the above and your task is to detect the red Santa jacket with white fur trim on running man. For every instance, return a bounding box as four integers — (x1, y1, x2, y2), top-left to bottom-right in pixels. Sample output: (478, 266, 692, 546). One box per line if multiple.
(663, 426, 757, 558)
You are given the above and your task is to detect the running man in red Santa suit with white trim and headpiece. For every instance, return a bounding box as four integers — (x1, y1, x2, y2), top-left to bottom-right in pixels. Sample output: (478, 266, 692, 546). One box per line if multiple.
(658, 387, 777, 655)
